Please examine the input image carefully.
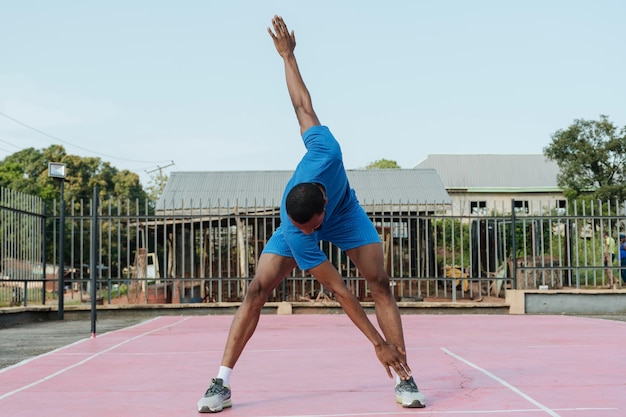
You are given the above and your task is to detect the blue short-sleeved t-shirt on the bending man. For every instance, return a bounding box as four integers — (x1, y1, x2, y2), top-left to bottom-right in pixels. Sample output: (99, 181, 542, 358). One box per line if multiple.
(280, 126, 358, 269)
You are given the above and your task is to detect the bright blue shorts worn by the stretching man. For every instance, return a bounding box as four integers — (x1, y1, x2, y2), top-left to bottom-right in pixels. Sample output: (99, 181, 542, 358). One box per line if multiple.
(263, 201, 381, 259)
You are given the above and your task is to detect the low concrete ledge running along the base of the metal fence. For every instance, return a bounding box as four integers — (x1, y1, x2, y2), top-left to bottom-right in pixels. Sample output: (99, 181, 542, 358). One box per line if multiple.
(0, 289, 626, 328)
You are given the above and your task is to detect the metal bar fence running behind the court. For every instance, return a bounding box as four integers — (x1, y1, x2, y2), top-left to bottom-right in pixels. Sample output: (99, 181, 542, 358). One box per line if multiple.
(0, 187, 626, 305)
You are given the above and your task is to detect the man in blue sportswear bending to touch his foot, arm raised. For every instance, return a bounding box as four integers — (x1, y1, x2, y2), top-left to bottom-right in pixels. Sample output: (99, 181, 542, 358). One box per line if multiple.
(198, 16, 426, 413)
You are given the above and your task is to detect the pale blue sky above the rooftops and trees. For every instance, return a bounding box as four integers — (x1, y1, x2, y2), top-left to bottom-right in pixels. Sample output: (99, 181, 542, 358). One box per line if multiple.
(0, 0, 626, 185)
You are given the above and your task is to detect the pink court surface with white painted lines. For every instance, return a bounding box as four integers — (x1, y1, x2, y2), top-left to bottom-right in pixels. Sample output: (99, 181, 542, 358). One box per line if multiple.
(0, 314, 626, 417)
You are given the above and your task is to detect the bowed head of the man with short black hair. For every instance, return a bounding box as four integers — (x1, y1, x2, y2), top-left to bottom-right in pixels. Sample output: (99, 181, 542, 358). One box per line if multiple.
(285, 182, 326, 234)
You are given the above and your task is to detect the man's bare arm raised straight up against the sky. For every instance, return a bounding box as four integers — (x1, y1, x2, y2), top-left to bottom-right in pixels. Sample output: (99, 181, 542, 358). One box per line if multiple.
(267, 16, 320, 134)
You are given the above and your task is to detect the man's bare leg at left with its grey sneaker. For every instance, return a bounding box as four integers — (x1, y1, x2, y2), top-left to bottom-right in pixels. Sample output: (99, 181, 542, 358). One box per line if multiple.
(198, 253, 296, 413)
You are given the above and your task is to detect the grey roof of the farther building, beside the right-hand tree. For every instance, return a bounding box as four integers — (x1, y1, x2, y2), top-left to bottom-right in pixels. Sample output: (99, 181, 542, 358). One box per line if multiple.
(416, 154, 561, 191)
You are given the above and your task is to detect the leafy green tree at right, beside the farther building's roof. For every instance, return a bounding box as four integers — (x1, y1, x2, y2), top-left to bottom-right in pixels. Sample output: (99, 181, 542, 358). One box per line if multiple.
(544, 115, 626, 200)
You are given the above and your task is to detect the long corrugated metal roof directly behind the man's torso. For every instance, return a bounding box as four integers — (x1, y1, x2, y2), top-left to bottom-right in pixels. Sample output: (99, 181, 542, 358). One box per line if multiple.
(156, 169, 451, 210)
